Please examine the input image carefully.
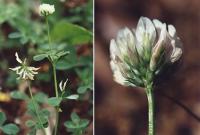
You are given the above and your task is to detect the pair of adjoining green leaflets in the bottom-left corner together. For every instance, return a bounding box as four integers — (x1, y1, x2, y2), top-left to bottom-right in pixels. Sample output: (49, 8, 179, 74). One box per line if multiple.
(0, 112, 19, 135)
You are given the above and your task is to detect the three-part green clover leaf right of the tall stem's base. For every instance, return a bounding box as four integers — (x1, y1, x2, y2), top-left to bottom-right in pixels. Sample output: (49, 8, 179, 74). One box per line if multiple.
(64, 112, 89, 135)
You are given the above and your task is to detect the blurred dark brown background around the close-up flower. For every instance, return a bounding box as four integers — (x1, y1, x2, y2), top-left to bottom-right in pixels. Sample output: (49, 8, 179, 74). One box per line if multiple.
(95, 0, 200, 135)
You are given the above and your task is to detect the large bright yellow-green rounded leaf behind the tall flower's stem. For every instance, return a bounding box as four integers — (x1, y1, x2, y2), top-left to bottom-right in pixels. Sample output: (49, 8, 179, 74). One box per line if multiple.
(51, 20, 92, 45)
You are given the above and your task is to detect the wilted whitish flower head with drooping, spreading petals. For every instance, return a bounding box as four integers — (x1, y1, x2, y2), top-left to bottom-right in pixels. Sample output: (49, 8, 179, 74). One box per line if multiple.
(9, 52, 39, 80)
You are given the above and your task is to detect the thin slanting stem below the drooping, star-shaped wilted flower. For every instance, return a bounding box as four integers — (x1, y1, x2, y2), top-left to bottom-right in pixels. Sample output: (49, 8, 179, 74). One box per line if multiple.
(27, 82, 46, 135)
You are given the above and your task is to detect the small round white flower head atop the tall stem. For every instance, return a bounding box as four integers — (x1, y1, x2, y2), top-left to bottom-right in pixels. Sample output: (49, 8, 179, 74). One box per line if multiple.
(39, 3, 55, 16)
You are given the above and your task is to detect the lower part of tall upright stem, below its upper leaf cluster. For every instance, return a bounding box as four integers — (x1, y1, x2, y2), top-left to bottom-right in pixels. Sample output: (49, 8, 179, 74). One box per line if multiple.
(52, 63, 59, 135)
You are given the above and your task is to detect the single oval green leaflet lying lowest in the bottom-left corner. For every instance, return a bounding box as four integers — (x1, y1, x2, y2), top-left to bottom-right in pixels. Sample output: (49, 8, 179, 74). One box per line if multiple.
(1, 124, 19, 135)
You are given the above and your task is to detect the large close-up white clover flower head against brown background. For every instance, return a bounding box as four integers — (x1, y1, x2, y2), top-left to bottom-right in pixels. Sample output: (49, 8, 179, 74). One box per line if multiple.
(110, 17, 182, 87)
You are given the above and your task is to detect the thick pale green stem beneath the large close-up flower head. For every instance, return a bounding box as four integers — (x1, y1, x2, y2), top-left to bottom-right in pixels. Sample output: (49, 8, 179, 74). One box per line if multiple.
(146, 85, 155, 135)
